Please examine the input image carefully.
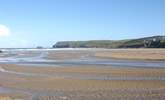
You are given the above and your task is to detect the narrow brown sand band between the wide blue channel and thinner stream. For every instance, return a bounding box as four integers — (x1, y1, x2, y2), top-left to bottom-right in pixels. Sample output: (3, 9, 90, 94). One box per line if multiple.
(0, 64, 165, 77)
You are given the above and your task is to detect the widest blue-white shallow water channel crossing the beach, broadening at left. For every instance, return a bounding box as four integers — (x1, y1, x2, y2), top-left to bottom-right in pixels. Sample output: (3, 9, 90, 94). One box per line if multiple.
(0, 50, 165, 68)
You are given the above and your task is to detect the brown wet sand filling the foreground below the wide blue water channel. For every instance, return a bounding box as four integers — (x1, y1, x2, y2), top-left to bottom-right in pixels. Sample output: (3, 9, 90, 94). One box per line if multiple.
(0, 64, 165, 100)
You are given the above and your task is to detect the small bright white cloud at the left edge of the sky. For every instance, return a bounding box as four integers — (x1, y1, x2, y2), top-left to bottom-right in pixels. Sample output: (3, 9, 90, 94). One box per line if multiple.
(0, 24, 10, 37)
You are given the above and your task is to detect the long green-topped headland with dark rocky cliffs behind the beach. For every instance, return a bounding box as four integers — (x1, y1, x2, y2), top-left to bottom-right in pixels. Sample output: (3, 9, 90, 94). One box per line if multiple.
(53, 36, 165, 48)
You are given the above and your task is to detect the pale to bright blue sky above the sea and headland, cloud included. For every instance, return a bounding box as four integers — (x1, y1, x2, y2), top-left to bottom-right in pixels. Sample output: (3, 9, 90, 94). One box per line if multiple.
(0, 0, 165, 48)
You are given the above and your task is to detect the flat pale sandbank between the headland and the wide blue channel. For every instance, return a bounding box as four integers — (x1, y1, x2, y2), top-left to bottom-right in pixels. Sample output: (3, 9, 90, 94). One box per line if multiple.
(45, 48, 165, 60)
